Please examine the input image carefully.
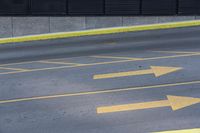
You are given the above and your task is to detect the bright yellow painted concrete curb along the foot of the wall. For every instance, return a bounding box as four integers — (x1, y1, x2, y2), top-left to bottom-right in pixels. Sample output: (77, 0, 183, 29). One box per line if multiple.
(0, 20, 200, 44)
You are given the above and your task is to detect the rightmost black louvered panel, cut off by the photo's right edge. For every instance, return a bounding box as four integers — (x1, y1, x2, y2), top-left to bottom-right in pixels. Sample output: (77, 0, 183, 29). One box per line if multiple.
(178, 0, 200, 15)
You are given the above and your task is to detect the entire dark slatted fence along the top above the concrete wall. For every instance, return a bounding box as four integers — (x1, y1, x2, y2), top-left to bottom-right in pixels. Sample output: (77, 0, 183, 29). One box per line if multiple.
(0, 0, 200, 16)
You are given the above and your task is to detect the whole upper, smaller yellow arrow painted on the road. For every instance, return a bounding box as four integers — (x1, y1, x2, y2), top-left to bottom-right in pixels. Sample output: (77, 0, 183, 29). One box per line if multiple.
(93, 66, 182, 79)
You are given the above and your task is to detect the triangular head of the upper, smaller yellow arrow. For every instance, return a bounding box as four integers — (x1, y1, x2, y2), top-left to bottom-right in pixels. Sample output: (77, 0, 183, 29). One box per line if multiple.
(151, 66, 182, 77)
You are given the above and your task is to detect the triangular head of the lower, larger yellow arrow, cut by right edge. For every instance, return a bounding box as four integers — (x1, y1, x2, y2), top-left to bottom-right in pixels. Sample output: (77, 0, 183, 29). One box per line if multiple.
(167, 95, 200, 111)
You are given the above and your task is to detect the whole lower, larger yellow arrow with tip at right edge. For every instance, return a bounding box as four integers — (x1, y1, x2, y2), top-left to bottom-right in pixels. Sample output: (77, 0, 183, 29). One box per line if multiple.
(97, 95, 200, 114)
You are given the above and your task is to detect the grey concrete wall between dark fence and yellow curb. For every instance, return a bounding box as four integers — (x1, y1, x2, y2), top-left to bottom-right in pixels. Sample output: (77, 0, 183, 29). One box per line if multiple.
(0, 16, 200, 38)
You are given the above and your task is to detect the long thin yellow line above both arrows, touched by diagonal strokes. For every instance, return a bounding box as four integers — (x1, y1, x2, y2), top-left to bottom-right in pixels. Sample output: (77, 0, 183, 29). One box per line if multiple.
(0, 53, 200, 75)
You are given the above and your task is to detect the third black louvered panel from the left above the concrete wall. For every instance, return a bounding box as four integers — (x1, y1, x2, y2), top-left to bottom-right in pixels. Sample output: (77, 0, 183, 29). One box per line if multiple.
(68, 0, 104, 15)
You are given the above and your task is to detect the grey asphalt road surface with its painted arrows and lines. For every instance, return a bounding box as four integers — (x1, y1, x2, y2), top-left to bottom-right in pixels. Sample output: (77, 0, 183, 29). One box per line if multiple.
(0, 27, 200, 133)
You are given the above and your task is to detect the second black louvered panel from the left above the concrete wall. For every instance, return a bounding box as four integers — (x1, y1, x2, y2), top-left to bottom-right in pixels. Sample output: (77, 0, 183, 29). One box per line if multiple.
(31, 0, 67, 15)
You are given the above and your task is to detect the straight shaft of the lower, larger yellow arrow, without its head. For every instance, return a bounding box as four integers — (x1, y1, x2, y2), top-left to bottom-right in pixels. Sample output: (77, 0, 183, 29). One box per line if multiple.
(97, 100, 170, 114)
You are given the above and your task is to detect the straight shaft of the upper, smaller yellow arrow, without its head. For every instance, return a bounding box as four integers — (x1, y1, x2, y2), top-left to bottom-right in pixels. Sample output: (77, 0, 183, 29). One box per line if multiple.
(93, 69, 154, 79)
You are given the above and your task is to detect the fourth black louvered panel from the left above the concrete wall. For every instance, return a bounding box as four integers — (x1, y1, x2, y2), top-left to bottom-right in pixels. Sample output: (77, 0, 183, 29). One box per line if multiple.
(105, 0, 140, 15)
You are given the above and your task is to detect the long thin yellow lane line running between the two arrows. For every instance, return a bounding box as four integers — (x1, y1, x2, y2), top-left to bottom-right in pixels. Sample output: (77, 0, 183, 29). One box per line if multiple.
(0, 80, 200, 104)
